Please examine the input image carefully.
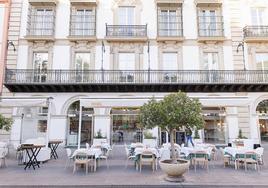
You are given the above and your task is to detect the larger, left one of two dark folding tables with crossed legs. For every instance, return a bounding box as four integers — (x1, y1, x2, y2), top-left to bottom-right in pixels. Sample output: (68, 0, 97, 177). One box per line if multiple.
(20, 144, 45, 170)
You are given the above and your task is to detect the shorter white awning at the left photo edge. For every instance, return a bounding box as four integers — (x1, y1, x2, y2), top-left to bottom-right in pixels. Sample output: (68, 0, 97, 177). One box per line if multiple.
(0, 97, 48, 107)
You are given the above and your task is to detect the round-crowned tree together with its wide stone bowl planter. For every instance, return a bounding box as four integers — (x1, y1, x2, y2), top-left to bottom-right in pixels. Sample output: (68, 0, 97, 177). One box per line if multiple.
(139, 92, 204, 182)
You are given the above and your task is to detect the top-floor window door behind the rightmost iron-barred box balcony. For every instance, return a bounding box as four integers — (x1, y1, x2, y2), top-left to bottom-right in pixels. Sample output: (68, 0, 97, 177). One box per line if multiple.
(199, 10, 219, 36)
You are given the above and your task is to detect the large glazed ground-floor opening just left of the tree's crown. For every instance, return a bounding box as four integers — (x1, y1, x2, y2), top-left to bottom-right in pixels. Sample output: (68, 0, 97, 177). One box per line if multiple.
(111, 108, 142, 144)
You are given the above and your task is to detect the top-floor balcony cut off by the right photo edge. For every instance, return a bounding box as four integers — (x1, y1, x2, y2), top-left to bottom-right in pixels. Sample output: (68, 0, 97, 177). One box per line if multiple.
(243, 26, 268, 42)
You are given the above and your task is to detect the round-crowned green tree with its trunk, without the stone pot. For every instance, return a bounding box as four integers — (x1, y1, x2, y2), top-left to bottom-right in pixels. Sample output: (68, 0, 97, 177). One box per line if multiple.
(139, 92, 204, 163)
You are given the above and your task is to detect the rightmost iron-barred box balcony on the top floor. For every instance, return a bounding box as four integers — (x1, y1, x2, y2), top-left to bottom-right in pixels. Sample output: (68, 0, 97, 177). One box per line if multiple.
(198, 16, 225, 42)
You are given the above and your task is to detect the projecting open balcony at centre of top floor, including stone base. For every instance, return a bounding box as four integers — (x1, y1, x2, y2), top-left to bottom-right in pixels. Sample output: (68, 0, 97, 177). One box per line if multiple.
(106, 25, 148, 42)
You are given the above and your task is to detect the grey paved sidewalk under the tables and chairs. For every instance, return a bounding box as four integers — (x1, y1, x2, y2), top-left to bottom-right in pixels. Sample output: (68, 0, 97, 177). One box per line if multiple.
(0, 144, 268, 188)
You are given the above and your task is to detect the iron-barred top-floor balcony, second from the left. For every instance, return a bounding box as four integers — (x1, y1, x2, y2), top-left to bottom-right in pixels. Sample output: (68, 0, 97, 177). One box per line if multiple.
(68, 14, 96, 41)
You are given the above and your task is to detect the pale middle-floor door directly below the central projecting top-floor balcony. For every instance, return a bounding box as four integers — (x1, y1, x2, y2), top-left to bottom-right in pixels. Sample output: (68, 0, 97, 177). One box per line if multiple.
(119, 53, 135, 82)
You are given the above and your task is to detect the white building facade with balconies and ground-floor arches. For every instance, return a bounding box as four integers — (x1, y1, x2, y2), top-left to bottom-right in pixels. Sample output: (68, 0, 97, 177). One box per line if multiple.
(2, 0, 268, 146)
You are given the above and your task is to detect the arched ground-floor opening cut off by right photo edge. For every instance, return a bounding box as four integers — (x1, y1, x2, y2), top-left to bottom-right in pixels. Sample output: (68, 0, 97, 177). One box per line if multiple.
(256, 100, 268, 142)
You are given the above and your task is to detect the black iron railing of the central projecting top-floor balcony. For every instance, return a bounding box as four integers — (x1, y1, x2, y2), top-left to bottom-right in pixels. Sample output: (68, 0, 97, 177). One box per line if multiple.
(106, 24, 147, 37)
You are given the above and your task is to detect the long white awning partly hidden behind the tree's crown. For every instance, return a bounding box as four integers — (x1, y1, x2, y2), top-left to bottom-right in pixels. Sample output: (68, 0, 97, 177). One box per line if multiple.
(80, 96, 250, 108)
